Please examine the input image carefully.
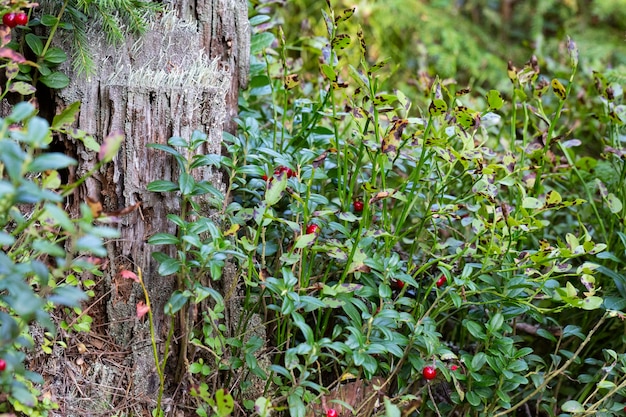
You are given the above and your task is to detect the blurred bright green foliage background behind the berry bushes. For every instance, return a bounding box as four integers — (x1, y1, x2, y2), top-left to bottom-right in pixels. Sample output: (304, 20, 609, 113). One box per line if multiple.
(267, 0, 626, 91)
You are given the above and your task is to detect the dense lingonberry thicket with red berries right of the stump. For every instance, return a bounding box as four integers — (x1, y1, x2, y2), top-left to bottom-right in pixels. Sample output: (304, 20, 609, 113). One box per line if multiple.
(177, 1, 626, 416)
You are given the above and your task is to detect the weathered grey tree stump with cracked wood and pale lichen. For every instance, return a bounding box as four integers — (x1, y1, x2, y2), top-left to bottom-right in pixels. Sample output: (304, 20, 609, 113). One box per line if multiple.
(42, 0, 249, 416)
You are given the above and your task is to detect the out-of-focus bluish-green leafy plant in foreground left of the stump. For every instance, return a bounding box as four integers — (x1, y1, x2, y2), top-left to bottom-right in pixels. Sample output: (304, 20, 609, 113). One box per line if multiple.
(0, 103, 120, 415)
